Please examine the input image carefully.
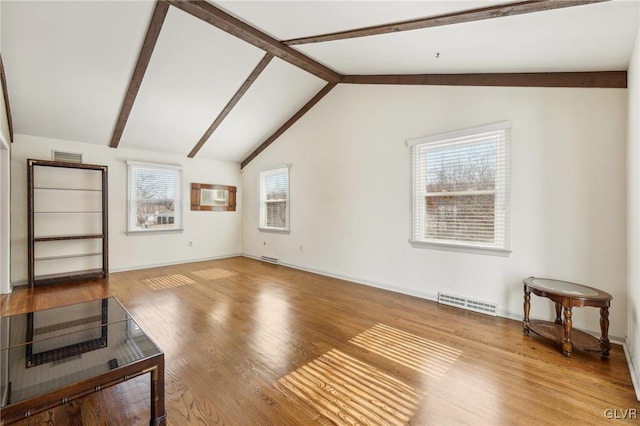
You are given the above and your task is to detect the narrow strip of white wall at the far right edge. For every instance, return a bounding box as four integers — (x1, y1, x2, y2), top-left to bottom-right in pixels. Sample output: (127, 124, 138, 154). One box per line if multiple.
(627, 31, 640, 400)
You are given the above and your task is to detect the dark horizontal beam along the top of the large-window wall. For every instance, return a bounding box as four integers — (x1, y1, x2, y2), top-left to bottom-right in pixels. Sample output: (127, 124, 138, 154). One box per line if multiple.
(342, 71, 627, 88)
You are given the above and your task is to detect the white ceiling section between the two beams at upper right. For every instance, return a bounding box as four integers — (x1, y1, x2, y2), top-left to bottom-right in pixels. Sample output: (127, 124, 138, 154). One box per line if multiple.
(299, 1, 638, 74)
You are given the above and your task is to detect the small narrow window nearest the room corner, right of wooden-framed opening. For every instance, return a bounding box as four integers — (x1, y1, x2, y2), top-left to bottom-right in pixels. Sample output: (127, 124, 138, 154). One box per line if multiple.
(259, 167, 289, 231)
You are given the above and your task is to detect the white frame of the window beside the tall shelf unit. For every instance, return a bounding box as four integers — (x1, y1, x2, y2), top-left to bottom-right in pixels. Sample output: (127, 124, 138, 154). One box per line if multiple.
(126, 161, 183, 235)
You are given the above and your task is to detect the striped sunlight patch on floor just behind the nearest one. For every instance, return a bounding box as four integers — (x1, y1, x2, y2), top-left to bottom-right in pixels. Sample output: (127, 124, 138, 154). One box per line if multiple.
(349, 324, 462, 378)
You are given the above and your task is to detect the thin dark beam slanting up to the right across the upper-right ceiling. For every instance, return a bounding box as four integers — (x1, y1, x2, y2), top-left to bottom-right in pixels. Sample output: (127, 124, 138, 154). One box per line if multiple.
(283, 0, 611, 46)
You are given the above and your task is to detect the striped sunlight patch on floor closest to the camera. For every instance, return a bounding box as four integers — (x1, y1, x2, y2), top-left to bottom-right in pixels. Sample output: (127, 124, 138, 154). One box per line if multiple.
(277, 349, 422, 425)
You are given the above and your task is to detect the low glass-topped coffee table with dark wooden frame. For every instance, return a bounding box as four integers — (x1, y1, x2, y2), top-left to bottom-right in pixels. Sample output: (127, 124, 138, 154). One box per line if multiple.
(0, 297, 166, 425)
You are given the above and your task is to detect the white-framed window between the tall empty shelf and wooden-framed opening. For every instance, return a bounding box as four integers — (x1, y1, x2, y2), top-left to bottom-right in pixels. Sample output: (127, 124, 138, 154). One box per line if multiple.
(127, 161, 182, 232)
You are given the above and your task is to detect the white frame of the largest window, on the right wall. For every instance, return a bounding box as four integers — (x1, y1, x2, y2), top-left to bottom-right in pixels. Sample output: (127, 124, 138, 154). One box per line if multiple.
(407, 121, 511, 256)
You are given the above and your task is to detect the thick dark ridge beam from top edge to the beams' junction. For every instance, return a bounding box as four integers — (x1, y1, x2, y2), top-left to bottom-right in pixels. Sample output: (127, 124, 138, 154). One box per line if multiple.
(167, 0, 342, 83)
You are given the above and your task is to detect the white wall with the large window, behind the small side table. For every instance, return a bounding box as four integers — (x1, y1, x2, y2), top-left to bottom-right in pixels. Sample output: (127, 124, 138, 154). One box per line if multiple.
(242, 85, 627, 337)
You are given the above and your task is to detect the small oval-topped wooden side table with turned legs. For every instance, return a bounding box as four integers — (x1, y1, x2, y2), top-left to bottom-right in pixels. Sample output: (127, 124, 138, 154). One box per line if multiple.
(522, 277, 612, 357)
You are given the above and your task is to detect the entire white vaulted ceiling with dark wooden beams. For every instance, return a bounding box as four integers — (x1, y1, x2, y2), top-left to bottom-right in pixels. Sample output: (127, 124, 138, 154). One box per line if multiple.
(0, 0, 640, 166)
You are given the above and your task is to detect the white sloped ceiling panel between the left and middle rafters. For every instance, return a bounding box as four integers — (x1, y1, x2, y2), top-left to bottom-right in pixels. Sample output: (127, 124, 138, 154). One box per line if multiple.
(120, 7, 264, 156)
